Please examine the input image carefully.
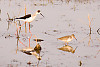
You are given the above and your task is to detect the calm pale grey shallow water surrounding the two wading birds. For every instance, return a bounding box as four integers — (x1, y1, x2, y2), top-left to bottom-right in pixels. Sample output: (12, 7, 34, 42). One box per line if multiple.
(0, 0, 100, 67)
